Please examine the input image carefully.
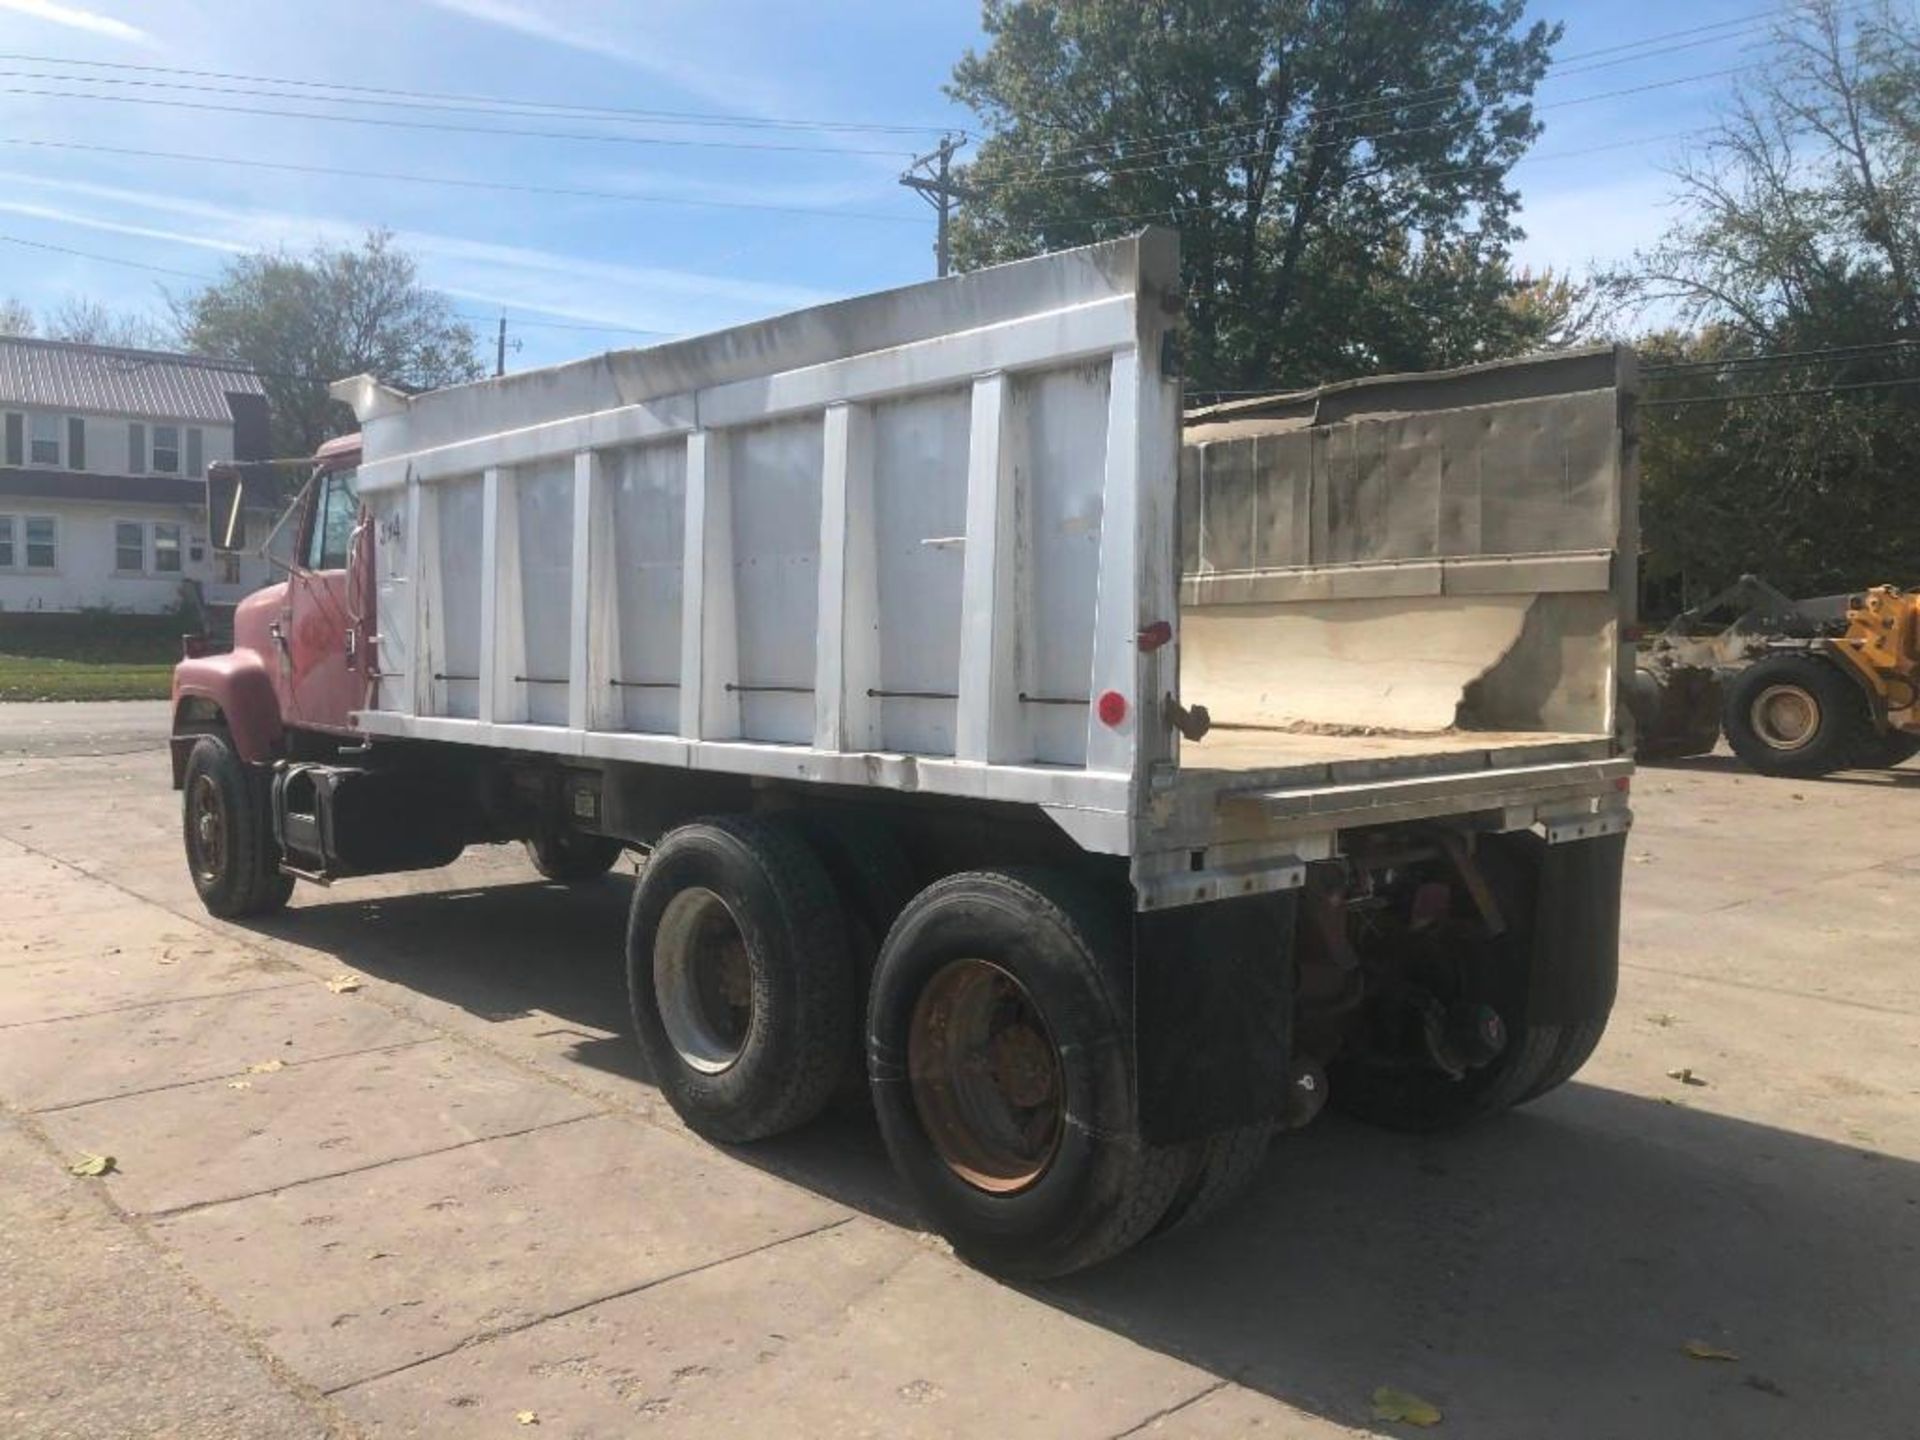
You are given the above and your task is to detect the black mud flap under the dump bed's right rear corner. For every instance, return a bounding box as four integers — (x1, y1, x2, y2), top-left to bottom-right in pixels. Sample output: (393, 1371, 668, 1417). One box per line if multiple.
(1526, 833, 1626, 1025)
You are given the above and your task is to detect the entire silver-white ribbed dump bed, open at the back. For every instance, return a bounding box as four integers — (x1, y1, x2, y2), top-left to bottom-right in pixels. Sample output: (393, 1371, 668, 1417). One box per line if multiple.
(336, 230, 1632, 899)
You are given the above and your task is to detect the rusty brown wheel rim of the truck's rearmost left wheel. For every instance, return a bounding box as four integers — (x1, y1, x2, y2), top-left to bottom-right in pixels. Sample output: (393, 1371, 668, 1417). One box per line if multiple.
(906, 960, 1066, 1194)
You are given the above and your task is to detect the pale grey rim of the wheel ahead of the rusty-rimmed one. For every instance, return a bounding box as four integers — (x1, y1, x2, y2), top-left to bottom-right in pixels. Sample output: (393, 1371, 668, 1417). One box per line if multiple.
(653, 885, 755, 1075)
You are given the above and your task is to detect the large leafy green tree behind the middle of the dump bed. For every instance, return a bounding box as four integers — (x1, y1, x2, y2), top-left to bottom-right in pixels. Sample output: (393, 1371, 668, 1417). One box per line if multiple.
(948, 0, 1559, 390)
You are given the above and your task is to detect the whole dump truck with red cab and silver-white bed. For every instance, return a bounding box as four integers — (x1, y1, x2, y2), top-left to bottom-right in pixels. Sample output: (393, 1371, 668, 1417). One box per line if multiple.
(173, 230, 1636, 1277)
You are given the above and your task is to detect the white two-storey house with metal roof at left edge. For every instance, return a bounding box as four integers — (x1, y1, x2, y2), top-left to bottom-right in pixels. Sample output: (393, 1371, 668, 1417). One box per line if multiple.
(0, 336, 269, 612)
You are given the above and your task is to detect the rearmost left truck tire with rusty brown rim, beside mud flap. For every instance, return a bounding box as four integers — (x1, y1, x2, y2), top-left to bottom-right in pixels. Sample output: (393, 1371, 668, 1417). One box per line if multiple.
(868, 870, 1190, 1279)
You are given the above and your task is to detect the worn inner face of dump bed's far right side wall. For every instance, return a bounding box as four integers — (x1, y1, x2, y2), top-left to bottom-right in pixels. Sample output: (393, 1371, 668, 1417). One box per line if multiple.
(1181, 348, 1636, 748)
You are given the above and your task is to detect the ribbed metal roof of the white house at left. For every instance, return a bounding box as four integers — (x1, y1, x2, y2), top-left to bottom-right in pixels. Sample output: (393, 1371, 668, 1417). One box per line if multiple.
(0, 336, 267, 424)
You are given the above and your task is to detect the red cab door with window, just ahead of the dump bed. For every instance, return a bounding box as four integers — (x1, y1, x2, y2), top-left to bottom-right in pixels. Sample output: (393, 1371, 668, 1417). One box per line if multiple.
(280, 470, 371, 730)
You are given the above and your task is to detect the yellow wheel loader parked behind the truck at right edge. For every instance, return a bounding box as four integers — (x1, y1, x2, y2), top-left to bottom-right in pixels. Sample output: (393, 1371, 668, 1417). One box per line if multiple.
(1628, 576, 1920, 778)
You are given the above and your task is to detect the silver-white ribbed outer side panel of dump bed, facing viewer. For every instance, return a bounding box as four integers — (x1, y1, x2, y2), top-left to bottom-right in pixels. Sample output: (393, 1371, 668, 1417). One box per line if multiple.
(353, 232, 1181, 851)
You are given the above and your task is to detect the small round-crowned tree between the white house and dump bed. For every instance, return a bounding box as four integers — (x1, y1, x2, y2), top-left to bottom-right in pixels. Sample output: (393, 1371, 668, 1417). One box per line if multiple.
(173, 230, 486, 455)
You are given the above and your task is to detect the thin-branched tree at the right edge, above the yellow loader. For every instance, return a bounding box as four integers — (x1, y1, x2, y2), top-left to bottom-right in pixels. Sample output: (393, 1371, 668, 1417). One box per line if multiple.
(1611, 0, 1920, 599)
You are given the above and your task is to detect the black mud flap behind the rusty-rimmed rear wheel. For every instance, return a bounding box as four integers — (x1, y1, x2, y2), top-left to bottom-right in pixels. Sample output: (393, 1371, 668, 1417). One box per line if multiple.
(1133, 891, 1300, 1144)
